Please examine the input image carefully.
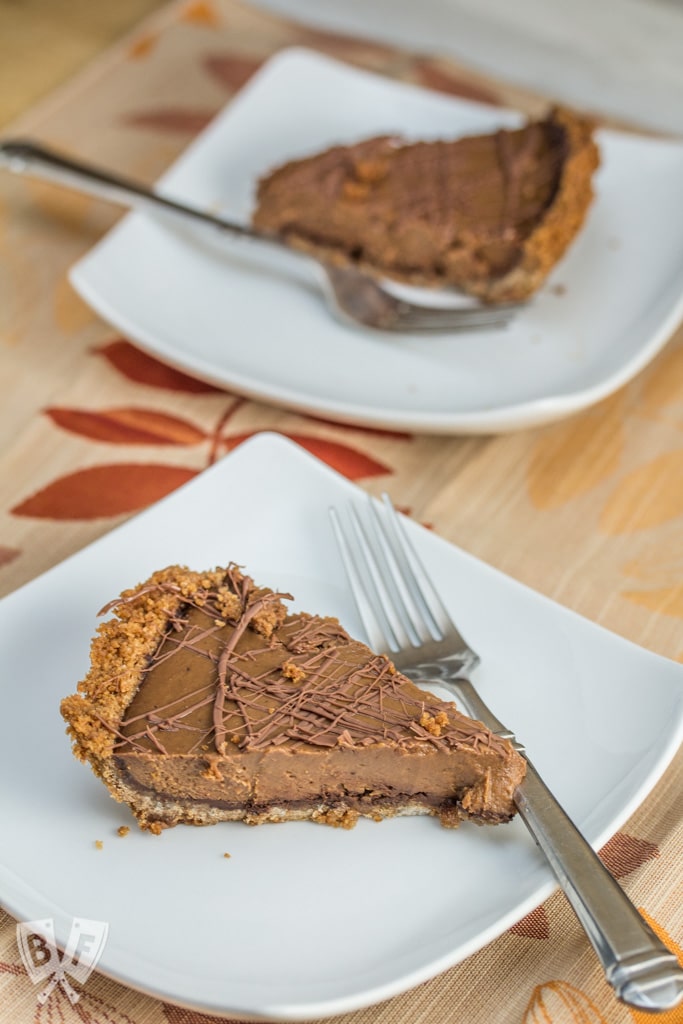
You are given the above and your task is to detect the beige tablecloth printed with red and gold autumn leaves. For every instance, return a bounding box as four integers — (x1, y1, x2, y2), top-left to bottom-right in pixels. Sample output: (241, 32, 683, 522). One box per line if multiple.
(0, 0, 683, 1024)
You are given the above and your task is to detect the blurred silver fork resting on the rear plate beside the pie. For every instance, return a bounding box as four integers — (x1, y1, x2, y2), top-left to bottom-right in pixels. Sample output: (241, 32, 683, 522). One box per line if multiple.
(0, 139, 524, 333)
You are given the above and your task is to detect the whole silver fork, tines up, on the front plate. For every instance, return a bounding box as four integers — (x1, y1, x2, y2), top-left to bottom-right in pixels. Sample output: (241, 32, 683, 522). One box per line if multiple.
(330, 495, 683, 1012)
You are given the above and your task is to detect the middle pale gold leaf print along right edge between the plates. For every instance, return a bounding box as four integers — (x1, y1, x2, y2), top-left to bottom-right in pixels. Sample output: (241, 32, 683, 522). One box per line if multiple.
(600, 449, 683, 535)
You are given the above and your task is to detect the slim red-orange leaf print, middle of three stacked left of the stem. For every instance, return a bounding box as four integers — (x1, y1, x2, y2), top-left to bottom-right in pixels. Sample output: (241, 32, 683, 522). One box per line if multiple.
(45, 408, 206, 444)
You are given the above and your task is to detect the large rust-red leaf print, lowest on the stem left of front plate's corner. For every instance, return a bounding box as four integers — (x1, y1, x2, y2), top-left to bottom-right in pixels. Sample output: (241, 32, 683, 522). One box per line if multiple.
(11, 463, 198, 519)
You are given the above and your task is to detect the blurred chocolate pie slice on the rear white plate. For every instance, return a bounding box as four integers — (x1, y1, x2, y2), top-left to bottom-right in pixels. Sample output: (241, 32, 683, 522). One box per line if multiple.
(253, 110, 599, 303)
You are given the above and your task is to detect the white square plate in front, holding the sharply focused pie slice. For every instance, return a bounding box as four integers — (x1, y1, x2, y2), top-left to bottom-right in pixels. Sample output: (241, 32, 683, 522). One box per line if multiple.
(0, 434, 683, 1020)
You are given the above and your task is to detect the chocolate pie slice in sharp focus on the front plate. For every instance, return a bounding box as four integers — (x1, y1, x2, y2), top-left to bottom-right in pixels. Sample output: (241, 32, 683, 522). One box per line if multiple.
(61, 565, 525, 833)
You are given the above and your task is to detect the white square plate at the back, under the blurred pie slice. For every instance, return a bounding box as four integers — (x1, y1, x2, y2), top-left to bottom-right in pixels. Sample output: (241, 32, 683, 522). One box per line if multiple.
(72, 49, 683, 433)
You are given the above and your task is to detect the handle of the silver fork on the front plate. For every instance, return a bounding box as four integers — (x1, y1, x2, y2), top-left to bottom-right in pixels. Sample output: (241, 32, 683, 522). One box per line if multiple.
(448, 678, 683, 1011)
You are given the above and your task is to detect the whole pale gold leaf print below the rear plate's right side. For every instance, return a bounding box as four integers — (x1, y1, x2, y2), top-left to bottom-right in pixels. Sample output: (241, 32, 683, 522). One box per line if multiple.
(526, 395, 624, 509)
